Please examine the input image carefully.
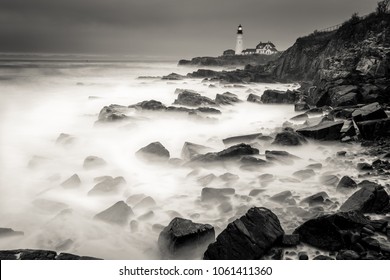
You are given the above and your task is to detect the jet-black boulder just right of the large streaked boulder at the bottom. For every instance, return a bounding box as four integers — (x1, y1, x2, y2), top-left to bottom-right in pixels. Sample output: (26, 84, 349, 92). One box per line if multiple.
(294, 212, 369, 251)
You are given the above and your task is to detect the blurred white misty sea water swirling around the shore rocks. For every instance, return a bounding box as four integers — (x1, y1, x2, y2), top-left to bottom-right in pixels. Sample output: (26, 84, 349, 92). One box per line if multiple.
(0, 62, 380, 259)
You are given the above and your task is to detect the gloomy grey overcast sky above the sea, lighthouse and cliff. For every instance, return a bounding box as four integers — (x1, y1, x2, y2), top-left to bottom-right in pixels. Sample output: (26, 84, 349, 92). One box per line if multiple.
(0, 0, 377, 58)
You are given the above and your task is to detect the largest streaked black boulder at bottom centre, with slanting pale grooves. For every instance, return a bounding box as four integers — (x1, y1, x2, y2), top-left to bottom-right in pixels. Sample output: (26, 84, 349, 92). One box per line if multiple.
(203, 207, 284, 260)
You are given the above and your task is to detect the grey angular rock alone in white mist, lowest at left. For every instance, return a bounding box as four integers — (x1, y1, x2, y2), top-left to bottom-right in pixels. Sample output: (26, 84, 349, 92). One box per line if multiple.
(94, 201, 134, 226)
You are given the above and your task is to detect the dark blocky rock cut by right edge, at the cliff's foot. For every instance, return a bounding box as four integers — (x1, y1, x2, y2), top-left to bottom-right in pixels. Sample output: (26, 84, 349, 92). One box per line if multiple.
(356, 118, 390, 140)
